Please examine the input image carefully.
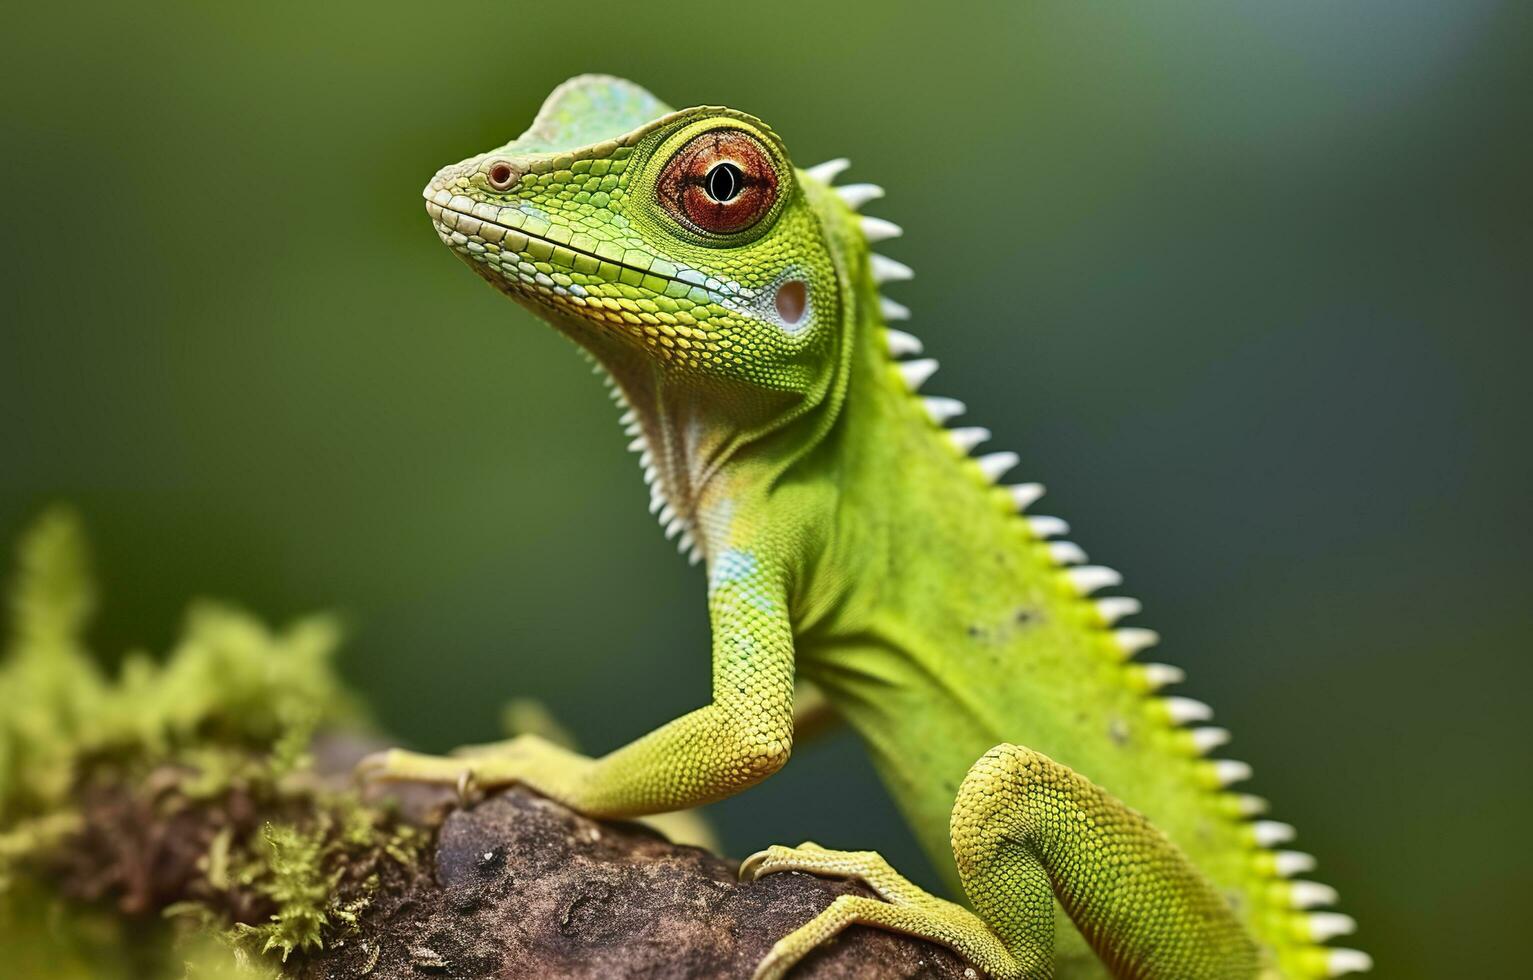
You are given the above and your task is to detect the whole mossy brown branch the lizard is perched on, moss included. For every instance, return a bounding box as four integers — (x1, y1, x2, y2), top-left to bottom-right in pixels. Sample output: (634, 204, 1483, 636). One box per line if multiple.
(0, 511, 972, 980)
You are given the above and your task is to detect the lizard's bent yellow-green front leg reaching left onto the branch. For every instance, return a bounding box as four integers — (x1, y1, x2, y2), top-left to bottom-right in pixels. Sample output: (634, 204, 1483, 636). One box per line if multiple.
(362, 549, 794, 817)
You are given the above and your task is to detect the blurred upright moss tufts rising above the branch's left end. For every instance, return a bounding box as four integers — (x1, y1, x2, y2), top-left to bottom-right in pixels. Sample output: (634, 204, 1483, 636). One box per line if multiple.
(0, 509, 357, 825)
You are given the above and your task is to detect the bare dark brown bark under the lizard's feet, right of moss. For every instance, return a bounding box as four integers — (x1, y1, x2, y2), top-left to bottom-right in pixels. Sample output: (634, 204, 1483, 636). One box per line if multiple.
(296, 790, 975, 980)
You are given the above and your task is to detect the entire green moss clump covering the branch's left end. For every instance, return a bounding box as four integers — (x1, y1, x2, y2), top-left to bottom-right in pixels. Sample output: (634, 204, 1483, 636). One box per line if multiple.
(0, 509, 425, 980)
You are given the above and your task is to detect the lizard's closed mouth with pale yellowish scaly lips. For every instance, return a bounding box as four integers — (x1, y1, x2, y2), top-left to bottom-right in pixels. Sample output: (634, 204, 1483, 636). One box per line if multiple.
(423, 187, 739, 304)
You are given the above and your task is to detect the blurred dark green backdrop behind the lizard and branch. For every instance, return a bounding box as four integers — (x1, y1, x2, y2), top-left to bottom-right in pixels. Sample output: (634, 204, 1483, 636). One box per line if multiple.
(0, 0, 1533, 977)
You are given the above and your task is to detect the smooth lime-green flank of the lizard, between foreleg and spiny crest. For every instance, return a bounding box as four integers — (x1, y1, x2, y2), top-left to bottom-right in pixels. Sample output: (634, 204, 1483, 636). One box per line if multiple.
(778, 211, 1285, 978)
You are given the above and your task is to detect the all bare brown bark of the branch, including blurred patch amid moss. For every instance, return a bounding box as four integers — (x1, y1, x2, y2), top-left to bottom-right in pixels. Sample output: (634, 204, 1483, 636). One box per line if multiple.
(44, 735, 978, 980)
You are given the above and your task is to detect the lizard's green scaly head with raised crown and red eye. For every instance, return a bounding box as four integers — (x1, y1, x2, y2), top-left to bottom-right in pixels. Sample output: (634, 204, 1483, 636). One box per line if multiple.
(425, 75, 840, 426)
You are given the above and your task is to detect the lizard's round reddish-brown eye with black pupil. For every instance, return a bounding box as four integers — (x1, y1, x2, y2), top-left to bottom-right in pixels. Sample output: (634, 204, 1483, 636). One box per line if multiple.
(656, 129, 777, 235)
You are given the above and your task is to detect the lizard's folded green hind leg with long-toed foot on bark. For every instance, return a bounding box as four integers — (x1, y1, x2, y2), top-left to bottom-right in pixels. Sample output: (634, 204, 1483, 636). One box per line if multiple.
(740, 745, 1260, 980)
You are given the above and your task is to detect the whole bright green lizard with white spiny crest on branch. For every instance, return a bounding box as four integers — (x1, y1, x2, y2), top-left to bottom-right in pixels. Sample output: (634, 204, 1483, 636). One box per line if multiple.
(365, 75, 1369, 978)
